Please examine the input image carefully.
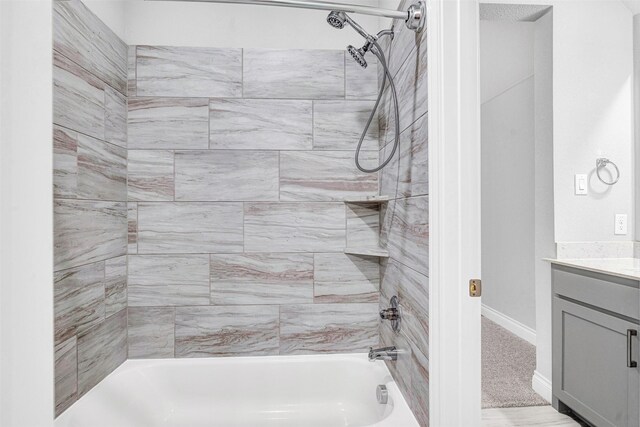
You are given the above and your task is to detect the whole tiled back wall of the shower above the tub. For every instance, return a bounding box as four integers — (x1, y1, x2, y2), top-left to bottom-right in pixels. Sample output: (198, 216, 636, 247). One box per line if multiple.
(128, 46, 380, 358)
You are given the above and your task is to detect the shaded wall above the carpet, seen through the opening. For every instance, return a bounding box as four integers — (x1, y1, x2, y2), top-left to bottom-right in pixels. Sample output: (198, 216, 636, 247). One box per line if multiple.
(480, 21, 536, 330)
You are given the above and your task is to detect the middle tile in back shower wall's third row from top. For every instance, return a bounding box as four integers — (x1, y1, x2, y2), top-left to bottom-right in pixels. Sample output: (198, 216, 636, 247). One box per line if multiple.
(175, 150, 279, 201)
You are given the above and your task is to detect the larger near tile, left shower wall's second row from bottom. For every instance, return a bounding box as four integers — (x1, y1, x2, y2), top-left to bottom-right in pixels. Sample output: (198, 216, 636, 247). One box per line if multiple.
(53, 262, 105, 343)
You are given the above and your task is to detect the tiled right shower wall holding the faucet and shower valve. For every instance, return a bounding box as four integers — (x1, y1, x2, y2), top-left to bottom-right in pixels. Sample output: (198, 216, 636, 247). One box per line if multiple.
(380, 1, 429, 426)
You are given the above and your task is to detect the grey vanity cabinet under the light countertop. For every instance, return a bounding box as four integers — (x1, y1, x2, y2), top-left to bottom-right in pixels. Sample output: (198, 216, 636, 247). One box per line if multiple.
(552, 265, 640, 427)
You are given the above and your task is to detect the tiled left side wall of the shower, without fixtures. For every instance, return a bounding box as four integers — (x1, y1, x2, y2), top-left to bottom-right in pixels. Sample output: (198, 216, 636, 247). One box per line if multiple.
(53, 0, 127, 414)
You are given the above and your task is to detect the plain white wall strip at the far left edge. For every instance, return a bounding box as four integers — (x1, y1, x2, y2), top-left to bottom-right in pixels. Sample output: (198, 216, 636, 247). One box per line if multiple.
(0, 0, 54, 427)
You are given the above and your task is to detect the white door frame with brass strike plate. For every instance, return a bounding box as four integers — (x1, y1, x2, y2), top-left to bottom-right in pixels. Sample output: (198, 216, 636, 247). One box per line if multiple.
(427, 0, 481, 427)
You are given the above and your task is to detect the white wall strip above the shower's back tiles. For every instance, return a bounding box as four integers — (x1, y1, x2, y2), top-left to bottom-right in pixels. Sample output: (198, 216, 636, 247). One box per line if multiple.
(84, 0, 399, 49)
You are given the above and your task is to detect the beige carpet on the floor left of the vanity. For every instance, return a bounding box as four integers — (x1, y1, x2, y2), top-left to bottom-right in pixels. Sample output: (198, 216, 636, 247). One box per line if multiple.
(482, 317, 549, 408)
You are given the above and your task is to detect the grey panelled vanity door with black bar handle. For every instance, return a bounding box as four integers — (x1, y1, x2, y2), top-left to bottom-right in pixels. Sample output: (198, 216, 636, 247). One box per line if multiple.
(553, 296, 640, 427)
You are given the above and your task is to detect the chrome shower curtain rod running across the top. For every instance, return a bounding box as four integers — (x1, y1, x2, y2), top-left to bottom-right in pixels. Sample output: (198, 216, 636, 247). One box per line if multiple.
(146, 0, 410, 21)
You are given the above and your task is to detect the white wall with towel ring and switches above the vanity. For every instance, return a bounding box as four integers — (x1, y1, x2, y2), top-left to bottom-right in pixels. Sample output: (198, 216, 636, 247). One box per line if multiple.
(483, 0, 634, 242)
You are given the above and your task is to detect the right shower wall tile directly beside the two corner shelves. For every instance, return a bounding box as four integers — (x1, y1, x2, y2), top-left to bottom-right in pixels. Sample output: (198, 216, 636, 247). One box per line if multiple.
(380, 196, 429, 276)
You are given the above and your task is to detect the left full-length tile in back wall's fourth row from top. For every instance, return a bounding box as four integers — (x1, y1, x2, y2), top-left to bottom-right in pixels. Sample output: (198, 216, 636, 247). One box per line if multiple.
(138, 202, 243, 254)
